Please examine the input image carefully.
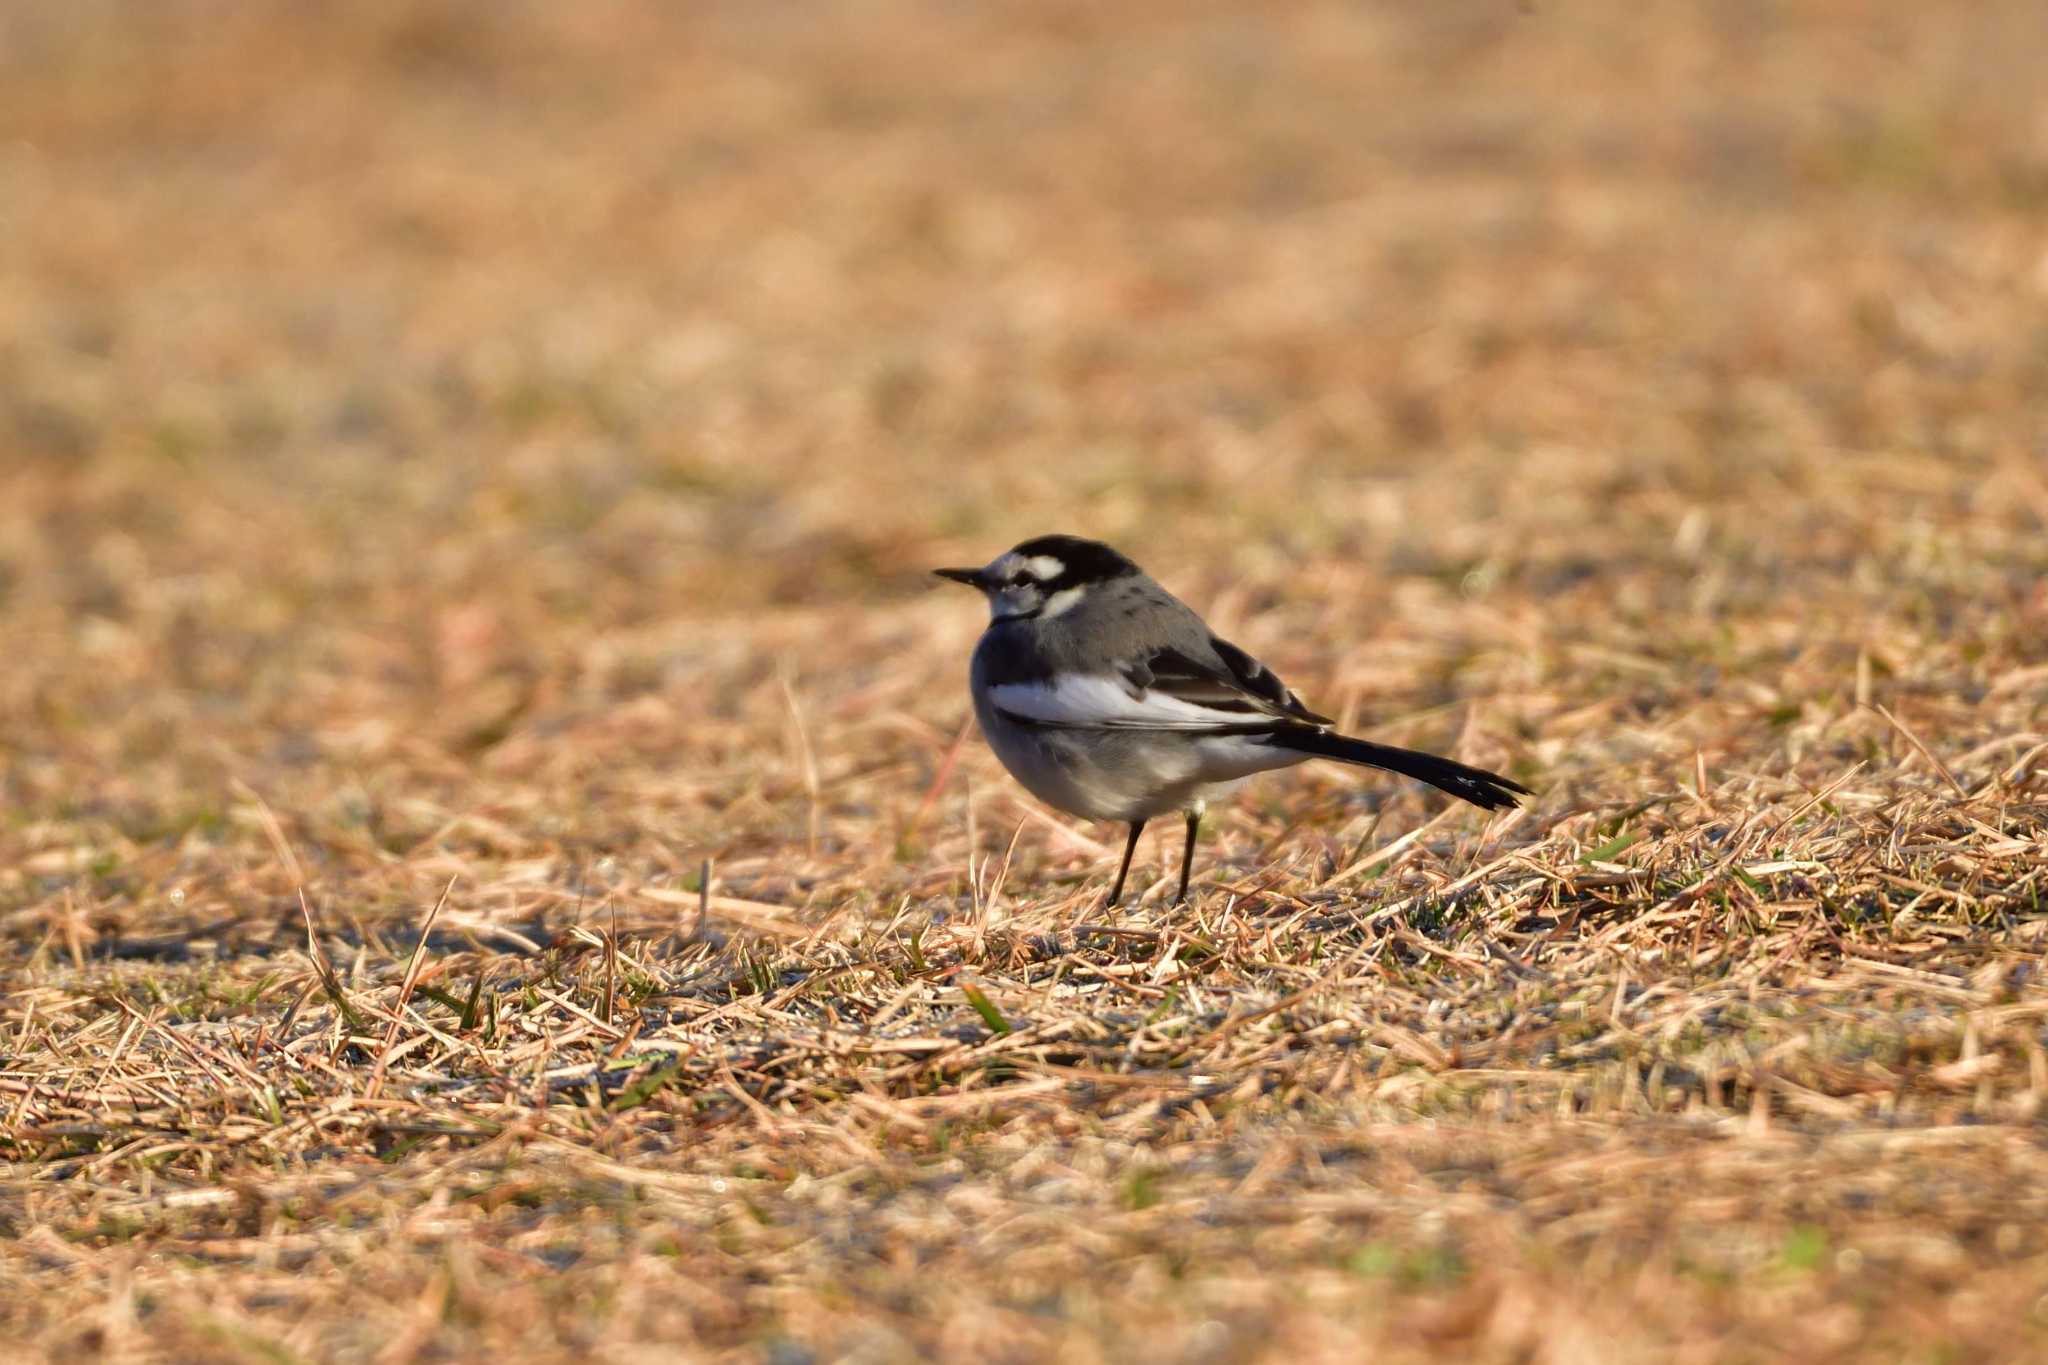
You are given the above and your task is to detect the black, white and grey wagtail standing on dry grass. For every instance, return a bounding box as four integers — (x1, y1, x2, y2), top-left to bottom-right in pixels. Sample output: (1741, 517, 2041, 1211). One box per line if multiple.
(934, 536, 1528, 905)
